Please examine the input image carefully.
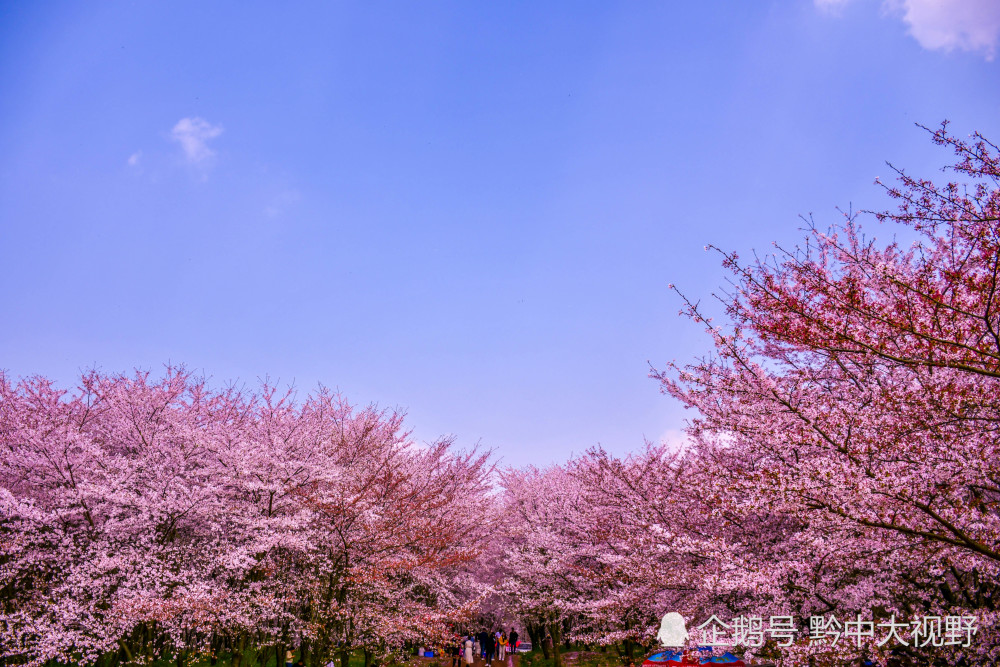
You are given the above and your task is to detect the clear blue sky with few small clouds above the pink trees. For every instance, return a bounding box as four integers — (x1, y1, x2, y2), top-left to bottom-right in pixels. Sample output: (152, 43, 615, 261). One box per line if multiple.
(0, 0, 1000, 465)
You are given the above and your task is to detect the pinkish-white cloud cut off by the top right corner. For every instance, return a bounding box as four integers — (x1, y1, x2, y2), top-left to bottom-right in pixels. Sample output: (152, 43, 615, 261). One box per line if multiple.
(813, 0, 1000, 60)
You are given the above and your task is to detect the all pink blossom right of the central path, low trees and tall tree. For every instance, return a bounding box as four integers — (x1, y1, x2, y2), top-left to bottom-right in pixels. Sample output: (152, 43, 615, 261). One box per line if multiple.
(490, 126, 1000, 665)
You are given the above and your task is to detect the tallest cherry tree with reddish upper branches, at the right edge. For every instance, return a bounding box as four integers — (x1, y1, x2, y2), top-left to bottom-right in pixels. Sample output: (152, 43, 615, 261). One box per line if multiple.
(656, 126, 1000, 664)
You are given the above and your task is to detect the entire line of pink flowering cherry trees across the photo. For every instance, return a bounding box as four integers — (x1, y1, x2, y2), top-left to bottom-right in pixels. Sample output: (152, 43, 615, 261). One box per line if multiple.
(0, 126, 1000, 667)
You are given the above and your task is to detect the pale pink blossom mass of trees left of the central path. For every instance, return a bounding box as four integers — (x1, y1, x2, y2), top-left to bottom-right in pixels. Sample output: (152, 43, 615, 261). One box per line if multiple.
(0, 368, 489, 667)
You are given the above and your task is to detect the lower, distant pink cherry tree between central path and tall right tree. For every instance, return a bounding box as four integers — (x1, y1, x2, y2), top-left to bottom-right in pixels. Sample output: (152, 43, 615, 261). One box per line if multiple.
(499, 454, 717, 660)
